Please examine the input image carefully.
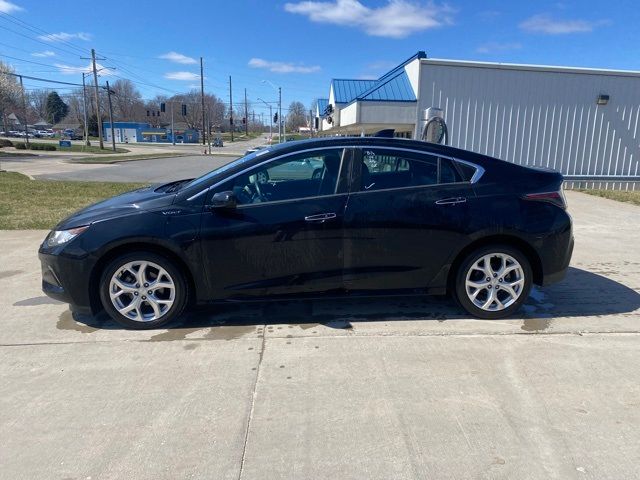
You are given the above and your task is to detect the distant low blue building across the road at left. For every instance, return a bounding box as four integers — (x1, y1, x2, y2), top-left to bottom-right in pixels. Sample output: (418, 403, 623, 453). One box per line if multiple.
(102, 122, 200, 143)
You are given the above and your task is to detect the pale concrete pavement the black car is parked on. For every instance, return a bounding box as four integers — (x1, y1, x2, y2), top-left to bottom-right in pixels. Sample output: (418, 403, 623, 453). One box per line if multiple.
(0, 192, 640, 480)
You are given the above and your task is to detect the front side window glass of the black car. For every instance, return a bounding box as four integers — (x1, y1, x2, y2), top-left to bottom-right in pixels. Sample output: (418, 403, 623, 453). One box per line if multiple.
(215, 148, 342, 205)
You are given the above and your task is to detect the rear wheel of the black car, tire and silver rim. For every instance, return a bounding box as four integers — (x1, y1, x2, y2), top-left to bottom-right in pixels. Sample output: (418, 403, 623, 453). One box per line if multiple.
(454, 245, 533, 319)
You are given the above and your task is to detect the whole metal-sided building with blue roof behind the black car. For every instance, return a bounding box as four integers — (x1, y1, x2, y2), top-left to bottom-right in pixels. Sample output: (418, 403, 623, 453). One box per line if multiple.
(319, 52, 640, 188)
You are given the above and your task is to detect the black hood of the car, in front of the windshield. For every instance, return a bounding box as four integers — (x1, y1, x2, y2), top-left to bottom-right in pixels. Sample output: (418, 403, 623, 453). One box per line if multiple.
(55, 184, 176, 230)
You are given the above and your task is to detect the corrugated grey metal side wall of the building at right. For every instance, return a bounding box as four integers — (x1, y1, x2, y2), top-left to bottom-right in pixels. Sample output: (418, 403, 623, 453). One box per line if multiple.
(418, 60, 640, 189)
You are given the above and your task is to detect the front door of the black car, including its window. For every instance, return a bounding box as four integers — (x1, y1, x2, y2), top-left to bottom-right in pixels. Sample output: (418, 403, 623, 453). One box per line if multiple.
(201, 148, 350, 299)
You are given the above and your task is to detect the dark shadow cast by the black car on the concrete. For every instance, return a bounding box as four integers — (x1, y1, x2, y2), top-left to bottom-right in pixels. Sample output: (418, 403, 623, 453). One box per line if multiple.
(73, 267, 640, 329)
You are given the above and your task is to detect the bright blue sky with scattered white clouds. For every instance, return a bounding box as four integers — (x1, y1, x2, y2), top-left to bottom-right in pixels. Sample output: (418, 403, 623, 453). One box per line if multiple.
(0, 0, 640, 111)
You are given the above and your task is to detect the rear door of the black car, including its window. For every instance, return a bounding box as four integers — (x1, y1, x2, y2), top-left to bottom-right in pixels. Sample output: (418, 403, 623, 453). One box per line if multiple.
(344, 147, 475, 291)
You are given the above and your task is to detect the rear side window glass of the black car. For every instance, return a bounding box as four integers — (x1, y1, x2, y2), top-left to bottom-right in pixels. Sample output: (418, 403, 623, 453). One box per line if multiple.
(360, 148, 473, 191)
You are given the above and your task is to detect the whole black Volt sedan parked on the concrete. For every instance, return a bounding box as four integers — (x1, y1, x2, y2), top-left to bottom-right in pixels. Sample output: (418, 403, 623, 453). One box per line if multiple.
(39, 137, 573, 328)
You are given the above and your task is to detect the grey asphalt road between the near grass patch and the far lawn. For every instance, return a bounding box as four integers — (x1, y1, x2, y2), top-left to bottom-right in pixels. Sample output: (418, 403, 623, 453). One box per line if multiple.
(12, 155, 237, 183)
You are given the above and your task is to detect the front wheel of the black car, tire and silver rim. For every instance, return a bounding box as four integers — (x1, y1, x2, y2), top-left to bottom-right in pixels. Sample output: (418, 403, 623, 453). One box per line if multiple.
(99, 251, 188, 329)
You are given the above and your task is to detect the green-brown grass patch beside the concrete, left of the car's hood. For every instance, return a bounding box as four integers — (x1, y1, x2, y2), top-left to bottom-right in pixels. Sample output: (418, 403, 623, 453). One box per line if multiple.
(0, 172, 144, 230)
